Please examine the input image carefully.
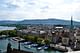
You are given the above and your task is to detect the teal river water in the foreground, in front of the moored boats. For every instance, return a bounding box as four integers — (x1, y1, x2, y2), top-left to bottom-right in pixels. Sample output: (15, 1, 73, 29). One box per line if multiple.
(0, 38, 63, 53)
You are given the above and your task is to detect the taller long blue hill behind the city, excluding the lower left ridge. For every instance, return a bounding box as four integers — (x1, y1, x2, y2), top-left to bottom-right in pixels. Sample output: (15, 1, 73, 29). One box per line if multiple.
(18, 19, 80, 25)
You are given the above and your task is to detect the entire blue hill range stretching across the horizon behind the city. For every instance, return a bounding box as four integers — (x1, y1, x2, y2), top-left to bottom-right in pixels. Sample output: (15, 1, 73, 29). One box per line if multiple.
(0, 19, 80, 25)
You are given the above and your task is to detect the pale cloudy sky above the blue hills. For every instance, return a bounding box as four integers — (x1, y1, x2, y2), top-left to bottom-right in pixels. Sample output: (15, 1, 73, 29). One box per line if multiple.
(0, 0, 80, 21)
